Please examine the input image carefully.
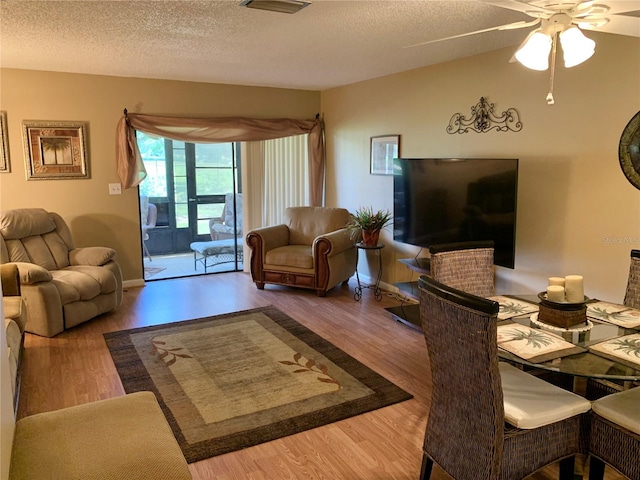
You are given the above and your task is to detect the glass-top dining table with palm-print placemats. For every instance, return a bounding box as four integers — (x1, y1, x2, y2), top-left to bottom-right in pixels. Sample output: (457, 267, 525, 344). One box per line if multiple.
(489, 294, 640, 395)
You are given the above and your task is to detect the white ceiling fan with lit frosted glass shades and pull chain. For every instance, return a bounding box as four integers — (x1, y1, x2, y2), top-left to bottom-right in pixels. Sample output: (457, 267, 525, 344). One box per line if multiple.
(405, 0, 640, 105)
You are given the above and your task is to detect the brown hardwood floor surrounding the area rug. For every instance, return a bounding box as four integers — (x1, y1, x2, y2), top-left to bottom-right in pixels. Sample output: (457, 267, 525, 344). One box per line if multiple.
(18, 273, 623, 480)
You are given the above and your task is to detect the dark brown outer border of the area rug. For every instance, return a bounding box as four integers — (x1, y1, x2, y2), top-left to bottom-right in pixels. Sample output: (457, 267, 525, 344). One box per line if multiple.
(104, 306, 413, 463)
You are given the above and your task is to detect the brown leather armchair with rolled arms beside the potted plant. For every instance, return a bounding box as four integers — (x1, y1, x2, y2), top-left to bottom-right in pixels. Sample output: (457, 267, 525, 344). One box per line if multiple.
(247, 207, 357, 297)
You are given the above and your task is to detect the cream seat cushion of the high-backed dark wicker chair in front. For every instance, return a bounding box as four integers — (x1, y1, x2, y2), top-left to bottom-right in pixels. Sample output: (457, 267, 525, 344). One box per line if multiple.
(499, 362, 591, 429)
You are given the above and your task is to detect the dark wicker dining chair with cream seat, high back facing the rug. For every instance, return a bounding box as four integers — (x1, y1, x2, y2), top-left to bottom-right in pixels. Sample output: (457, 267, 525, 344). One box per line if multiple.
(418, 276, 590, 480)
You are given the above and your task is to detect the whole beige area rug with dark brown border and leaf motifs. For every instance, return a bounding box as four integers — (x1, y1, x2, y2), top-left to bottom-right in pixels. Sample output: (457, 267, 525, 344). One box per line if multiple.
(104, 306, 412, 463)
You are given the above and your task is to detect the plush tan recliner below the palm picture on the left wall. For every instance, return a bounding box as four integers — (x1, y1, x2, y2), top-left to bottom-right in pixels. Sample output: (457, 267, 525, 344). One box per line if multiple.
(0, 208, 122, 337)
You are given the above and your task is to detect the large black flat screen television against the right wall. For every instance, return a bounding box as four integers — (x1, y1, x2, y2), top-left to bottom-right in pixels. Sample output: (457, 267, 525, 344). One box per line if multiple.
(393, 158, 518, 268)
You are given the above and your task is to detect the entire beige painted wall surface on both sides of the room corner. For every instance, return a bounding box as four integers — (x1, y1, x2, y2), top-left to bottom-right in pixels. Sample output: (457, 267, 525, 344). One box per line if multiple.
(0, 37, 640, 301)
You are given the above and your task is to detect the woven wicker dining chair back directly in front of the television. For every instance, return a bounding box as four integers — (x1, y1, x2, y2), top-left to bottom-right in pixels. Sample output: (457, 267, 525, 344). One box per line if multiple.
(429, 240, 495, 297)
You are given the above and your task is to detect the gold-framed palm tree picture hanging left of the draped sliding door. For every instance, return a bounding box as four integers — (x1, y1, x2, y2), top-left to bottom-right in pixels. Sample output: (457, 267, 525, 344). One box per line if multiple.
(22, 120, 89, 180)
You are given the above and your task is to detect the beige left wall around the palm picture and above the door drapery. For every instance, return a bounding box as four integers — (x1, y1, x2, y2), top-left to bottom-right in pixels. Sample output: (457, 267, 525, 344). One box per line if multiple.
(0, 69, 320, 281)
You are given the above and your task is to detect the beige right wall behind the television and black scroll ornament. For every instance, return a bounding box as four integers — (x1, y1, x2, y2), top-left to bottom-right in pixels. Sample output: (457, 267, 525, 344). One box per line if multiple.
(322, 33, 640, 302)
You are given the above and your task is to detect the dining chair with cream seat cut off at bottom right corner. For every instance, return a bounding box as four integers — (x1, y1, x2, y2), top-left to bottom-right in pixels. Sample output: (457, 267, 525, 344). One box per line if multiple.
(589, 387, 640, 480)
